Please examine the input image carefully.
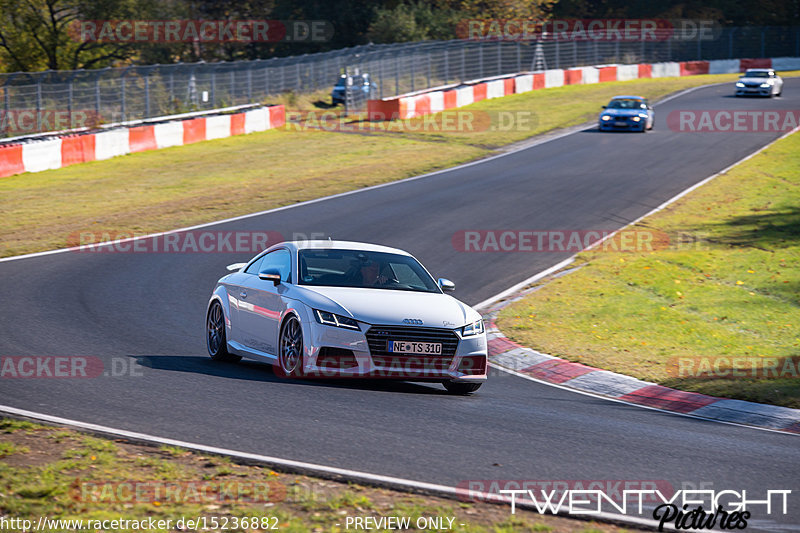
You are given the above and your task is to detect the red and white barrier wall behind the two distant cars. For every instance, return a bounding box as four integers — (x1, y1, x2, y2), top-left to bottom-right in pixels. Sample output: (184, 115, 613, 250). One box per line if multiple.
(368, 57, 800, 121)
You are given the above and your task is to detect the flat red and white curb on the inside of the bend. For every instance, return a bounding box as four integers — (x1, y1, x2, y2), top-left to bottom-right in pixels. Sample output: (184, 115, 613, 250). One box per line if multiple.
(486, 311, 800, 435)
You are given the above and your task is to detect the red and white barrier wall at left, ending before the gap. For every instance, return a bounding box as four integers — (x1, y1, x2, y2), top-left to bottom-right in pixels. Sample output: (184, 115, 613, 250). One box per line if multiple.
(0, 105, 286, 177)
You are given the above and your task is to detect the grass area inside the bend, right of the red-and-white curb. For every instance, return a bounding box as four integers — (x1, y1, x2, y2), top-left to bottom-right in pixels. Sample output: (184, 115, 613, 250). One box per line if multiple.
(498, 130, 800, 408)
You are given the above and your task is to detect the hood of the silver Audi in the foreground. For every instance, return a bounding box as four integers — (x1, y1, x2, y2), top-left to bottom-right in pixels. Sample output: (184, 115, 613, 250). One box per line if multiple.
(296, 287, 481, 329)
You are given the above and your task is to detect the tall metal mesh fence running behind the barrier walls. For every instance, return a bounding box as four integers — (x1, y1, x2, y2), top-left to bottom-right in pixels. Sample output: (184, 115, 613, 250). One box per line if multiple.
(0, 27, 800, 137)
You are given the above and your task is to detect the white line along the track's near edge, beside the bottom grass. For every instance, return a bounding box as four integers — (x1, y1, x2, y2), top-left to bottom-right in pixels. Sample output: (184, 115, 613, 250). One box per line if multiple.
(0, 405, 658, 528)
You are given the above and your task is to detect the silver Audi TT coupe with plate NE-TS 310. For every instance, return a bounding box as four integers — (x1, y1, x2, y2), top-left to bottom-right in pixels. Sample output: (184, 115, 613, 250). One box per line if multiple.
(206, 241, 487, 394)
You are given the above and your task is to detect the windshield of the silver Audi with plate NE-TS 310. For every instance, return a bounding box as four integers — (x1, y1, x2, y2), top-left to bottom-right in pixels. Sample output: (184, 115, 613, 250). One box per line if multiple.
(297, 249, 441, 292)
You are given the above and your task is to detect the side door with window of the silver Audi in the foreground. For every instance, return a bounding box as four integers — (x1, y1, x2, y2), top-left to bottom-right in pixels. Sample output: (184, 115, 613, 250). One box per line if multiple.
(239, 248, 292, 355)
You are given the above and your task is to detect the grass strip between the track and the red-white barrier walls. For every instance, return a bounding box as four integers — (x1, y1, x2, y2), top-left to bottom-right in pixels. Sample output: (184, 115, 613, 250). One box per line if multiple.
(0, 74, 780, 257)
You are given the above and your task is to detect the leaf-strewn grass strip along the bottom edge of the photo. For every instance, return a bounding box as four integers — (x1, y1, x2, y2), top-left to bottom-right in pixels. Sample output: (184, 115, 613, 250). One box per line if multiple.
(0, 419, 636, 533)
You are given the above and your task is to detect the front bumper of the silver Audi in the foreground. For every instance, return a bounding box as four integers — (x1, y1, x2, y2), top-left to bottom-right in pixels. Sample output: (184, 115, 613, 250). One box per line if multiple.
(304, 322, 488, 382)
